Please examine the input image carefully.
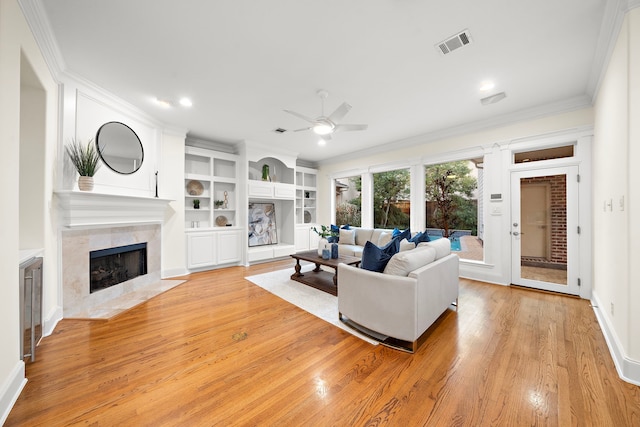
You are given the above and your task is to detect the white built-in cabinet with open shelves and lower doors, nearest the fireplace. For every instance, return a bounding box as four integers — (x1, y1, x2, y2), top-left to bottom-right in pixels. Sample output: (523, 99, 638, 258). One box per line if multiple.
(184, 146, 244, 269)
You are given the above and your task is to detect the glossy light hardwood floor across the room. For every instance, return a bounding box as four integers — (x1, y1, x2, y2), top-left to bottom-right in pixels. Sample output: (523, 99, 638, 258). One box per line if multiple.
(6, 261, 640, 426)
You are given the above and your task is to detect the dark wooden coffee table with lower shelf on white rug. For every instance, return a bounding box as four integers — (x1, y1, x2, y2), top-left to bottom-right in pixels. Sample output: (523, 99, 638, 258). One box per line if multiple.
(291, 250, 360, 296)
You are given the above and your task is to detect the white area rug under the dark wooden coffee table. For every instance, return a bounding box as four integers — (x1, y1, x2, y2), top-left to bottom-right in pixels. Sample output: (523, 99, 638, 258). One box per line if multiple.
(245, 264, 378, 345)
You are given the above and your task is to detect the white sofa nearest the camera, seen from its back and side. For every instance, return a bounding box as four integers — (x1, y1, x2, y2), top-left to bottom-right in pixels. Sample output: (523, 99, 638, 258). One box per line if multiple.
(338, 239, 459, 353)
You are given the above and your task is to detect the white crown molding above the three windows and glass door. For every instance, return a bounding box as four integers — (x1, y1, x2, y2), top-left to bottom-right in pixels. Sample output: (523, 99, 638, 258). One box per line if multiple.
(318, 95, 592, 165)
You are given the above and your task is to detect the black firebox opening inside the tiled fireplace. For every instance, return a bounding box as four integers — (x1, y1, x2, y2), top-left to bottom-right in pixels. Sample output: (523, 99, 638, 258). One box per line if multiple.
(89, 242, 147, 293)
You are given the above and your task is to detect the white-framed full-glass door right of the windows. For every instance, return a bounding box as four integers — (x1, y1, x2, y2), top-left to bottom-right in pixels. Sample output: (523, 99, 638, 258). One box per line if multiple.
(511, 166, 579, 295)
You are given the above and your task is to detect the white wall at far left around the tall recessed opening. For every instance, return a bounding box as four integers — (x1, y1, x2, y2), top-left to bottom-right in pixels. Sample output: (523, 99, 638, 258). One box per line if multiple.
(0, 0, 58, 422)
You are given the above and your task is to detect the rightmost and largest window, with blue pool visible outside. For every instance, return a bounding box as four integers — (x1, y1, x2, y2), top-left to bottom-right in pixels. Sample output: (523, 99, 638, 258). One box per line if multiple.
(425, 159, 484, 261)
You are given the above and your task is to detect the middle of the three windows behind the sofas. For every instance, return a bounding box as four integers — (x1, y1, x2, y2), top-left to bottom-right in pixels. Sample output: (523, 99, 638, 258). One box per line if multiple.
(373, 169, 411, 230)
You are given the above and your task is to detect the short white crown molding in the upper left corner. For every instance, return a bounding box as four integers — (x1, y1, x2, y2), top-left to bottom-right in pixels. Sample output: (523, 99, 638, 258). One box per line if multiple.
(18, 0, 67, 82)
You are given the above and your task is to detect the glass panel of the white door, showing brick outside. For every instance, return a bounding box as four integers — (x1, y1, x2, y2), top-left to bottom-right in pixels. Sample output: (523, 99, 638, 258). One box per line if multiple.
(520, 175, 567, 285)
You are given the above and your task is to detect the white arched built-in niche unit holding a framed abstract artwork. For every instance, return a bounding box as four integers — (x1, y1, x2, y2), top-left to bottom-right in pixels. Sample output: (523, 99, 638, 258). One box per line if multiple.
(247, 149, 296, 263)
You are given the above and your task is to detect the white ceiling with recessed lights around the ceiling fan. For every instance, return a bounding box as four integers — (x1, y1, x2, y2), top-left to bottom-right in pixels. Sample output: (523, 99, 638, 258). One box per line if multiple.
(37, 0, 611, 162)
